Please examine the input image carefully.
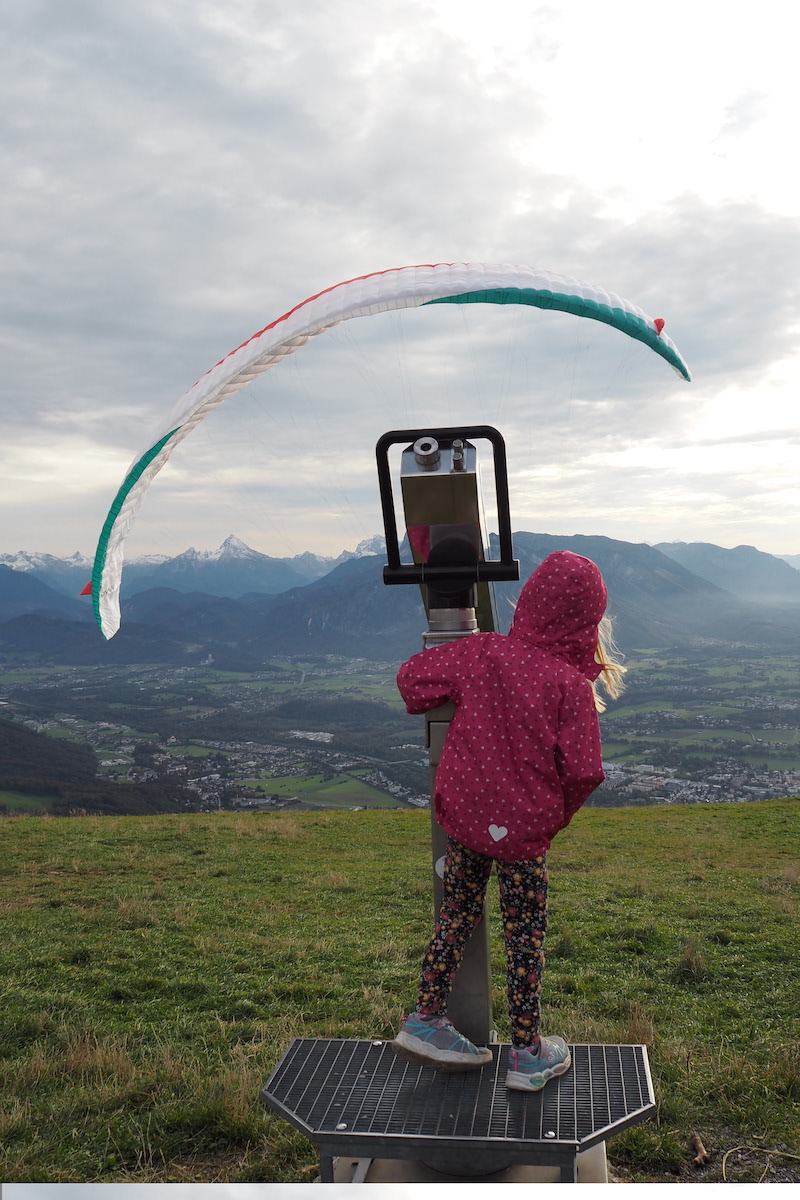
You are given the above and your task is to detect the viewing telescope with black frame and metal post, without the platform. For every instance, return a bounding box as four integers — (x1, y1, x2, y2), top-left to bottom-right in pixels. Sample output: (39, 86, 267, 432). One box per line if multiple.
(377, 425, 519, 1045)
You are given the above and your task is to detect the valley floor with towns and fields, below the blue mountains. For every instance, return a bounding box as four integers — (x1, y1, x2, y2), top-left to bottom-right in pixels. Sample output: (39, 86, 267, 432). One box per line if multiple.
(0, 641, 800, 811)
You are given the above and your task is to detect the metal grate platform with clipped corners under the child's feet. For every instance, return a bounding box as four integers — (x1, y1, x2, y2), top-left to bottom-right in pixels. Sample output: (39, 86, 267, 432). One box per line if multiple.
(261, 1038, 655, 1180)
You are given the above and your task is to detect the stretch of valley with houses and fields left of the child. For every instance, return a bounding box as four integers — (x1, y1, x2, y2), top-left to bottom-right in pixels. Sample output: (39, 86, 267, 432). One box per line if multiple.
(0, 658, 428, 811)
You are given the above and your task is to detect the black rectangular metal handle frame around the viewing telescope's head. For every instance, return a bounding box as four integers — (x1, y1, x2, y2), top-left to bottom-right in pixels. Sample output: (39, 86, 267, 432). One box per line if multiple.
(375, 425, 519, 588)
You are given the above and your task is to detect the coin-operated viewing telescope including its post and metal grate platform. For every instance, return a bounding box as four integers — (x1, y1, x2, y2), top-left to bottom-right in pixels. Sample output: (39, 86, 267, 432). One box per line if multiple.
(261, 425, 655, 1183)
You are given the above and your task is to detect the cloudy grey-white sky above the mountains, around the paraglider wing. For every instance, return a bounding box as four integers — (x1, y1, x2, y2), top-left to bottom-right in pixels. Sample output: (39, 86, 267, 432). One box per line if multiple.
(0, 0, 800, 557)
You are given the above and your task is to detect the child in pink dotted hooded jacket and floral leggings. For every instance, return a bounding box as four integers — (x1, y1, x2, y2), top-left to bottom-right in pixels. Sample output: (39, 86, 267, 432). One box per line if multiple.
(392, 551, 625, 1091)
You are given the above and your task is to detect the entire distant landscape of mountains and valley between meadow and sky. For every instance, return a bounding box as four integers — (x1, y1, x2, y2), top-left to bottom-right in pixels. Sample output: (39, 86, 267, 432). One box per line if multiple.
(0, 532, 800, 815)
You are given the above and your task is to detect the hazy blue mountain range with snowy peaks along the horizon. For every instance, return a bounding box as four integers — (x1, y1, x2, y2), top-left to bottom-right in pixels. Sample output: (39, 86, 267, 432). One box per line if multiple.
(0, 532, 800, 670)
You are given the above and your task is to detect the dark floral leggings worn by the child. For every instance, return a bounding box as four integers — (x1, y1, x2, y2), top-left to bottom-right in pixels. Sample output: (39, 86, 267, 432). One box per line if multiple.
(416, 838, 547, 1046)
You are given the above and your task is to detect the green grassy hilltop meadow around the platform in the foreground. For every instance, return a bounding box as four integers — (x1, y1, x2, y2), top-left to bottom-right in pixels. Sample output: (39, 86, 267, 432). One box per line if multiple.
(0, 800, 800, 1183)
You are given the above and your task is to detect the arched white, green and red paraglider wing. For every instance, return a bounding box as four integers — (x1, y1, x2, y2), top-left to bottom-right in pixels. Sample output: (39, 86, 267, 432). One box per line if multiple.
(91, 263, 691, 638)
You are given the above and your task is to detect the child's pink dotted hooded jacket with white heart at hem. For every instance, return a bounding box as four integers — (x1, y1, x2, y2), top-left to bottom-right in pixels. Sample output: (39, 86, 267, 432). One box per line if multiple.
(397, 551, 607, 862)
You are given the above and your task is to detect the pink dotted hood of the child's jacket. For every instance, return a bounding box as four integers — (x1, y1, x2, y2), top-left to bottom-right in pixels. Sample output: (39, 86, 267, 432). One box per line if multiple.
(510, 550, 608, 679)
